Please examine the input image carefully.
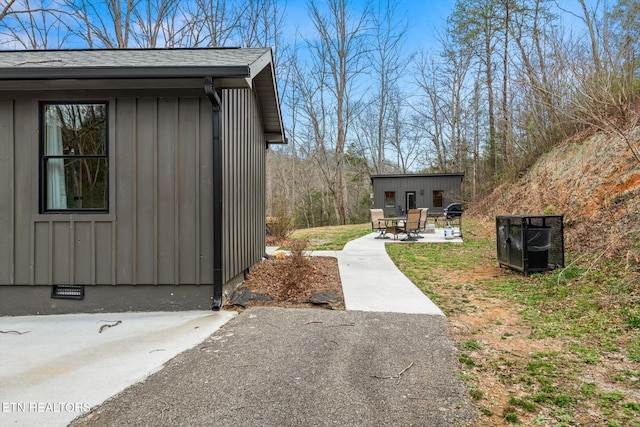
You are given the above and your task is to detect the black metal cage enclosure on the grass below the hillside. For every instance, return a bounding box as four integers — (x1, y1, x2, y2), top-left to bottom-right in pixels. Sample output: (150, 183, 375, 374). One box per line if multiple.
(496, 215, 564, 274)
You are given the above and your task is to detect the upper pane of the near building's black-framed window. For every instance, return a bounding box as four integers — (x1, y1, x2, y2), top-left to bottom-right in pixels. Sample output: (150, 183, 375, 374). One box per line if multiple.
(44, 104, 107, 156)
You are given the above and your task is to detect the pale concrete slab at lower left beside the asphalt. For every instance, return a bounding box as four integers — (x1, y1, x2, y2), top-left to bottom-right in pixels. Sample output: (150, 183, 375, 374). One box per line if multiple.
(0, 311, 236, 426)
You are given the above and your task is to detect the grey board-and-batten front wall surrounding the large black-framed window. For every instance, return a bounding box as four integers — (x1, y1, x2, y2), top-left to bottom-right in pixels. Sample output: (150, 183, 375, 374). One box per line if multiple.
(0, 96, 213, 285)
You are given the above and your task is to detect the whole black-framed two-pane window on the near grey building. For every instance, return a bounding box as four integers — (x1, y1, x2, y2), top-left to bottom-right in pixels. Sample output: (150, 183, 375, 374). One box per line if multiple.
(40, 103, 109, 212)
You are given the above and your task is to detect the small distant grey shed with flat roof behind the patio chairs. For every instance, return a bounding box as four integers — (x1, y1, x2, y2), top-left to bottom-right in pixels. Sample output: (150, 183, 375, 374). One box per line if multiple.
(371, 173, 464, 216)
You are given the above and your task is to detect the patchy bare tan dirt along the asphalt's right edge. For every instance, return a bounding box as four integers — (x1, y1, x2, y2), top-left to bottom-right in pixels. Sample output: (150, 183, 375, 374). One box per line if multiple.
(431, 254, 640, 427)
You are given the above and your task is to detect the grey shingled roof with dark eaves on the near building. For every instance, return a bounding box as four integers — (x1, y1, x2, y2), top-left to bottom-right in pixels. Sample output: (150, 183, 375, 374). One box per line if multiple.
(0, 48, 284, 143)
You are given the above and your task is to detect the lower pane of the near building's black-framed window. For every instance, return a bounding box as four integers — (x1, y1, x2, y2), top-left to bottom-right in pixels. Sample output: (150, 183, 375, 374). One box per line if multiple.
(45, 158, 109, 209)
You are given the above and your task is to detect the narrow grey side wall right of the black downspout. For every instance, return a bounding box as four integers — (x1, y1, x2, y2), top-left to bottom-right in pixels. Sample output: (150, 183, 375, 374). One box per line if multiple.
(222, 89, 267, 283)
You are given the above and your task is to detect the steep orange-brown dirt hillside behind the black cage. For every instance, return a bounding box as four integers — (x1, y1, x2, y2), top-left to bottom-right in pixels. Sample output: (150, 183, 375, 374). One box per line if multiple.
(468, 126, 640, 258)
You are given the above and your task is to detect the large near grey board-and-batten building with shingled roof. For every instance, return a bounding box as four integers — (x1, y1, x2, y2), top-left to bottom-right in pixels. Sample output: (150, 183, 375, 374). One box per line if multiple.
(0, 48, 285, 315)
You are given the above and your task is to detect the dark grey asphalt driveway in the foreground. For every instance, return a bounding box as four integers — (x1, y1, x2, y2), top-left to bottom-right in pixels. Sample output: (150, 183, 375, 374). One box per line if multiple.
(72, 308, 473, 426)
